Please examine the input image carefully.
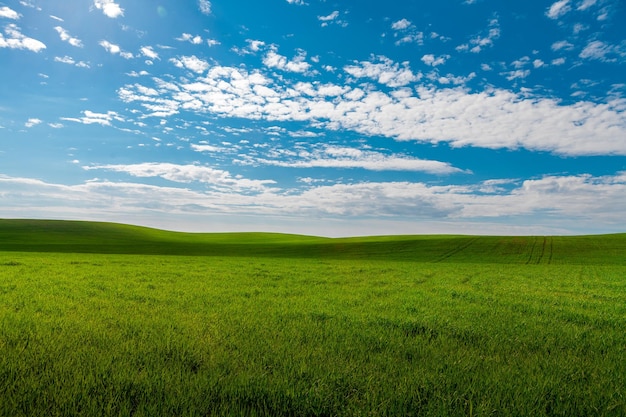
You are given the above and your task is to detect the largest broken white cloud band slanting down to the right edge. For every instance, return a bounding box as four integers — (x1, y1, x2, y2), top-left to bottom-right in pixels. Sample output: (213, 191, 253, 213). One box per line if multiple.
(118, 58, 626, 155)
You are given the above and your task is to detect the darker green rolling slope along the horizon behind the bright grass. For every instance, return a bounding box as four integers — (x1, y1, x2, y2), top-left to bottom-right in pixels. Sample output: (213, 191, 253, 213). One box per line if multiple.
(0, 219, 626, 265)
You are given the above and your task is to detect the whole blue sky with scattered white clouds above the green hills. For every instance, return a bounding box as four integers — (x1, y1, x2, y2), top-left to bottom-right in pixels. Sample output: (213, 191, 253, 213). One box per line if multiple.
(0, 0, 626, 237)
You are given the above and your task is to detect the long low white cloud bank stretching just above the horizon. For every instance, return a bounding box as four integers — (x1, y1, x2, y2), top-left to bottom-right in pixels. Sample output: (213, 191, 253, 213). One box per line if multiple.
(0, 169, 626, 234)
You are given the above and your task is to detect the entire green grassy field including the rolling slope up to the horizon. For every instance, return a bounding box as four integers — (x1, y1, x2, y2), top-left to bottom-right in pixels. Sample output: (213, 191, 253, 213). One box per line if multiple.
(0, 220, 626, 416)
